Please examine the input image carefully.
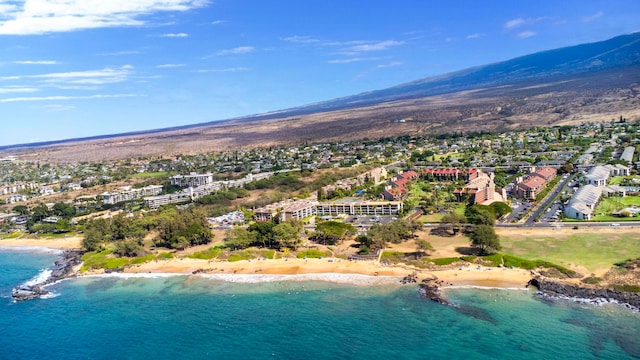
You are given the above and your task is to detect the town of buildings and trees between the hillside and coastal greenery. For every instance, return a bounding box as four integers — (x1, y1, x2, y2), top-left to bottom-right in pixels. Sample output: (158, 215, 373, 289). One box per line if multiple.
(0, 117, 640, 239)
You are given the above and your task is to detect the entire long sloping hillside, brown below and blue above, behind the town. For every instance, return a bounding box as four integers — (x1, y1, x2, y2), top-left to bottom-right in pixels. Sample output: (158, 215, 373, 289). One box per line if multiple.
(2, 33, 640, 161)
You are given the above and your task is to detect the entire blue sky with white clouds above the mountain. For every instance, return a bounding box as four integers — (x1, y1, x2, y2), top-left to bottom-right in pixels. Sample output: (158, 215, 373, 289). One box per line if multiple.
(0, 0, 640, 145)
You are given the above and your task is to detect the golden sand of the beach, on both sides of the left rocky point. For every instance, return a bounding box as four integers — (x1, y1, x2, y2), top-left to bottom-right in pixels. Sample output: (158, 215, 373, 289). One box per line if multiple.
(0, 237, 530, 288)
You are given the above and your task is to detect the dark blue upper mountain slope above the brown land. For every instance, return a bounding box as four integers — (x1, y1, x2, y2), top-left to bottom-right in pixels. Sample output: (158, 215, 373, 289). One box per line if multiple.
(239, 32, 640, 119)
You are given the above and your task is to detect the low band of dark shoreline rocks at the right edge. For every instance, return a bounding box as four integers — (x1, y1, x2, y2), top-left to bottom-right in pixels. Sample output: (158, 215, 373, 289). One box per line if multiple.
(527, 276, 640, 311)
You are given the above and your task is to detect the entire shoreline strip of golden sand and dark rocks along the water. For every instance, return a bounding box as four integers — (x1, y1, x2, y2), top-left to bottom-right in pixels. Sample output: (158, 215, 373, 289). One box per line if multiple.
(6, 245, 640, 312)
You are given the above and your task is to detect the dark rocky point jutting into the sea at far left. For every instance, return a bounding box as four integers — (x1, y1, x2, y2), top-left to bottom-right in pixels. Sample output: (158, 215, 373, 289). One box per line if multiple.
(11, 250, 83, 301)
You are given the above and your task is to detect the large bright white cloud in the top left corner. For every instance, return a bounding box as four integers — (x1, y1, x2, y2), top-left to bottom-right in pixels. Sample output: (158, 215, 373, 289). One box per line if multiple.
(0, 0, 208, 35)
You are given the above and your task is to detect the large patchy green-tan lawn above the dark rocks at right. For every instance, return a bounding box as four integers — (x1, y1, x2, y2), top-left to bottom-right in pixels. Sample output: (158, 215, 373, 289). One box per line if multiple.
(500, 229, 640, 275)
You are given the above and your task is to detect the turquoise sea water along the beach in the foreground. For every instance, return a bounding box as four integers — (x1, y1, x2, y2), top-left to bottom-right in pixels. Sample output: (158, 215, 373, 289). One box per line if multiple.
(0, 252, 640, 359)
